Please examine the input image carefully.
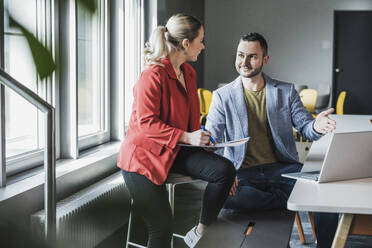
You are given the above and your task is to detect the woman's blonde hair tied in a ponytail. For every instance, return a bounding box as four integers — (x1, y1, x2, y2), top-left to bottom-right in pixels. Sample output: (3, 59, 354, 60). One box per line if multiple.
(143, 14, 202, 67)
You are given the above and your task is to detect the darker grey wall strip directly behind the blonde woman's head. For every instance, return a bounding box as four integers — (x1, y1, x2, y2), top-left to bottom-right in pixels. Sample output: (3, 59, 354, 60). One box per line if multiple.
(157, 0, 205, 87)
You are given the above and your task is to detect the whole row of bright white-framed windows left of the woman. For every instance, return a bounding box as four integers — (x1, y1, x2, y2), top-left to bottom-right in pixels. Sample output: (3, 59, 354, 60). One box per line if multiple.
(0, 0, 156, 182)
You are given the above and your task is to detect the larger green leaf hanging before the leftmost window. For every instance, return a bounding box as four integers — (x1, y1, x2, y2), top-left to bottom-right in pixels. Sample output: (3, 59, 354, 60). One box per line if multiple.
(9, 15, 56, 79)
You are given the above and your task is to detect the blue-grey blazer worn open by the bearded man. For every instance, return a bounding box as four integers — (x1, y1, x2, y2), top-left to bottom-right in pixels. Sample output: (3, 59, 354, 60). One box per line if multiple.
(206, 74, 322, 169)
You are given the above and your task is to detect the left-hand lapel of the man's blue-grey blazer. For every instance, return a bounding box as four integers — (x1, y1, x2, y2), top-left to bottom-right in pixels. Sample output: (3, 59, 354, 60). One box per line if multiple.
(230, 77, 248, 137)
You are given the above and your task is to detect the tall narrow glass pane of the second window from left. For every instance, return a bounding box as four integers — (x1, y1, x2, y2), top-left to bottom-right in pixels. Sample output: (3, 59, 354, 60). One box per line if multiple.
(77, 1, 106, 137)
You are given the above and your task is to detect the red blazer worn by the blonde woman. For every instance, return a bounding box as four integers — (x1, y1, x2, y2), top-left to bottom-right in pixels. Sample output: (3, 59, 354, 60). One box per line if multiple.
(117, 59, 200, 185)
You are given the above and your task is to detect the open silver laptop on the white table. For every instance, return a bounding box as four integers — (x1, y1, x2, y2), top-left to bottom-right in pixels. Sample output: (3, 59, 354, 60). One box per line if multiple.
(282, 131, 372, 183)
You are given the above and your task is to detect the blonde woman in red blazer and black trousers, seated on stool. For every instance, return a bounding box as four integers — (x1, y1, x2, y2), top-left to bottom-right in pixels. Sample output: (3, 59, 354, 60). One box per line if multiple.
(118, 14, 235, 248)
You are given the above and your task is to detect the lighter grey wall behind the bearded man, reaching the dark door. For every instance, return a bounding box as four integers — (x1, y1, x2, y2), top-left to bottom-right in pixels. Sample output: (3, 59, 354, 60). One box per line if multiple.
(204, 0, 372, 94)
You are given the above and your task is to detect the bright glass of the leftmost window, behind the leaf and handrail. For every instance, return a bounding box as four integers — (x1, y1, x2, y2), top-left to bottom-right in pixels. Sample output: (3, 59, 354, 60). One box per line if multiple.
(3, 0, 50, 167)
